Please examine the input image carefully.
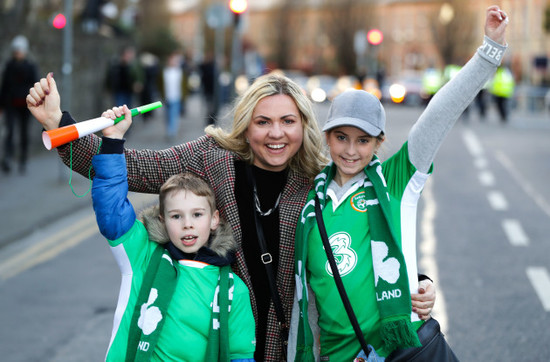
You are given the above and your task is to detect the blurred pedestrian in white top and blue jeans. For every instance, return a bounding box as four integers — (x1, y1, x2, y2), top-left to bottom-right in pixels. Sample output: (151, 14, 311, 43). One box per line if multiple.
(161, 52, 185, 142)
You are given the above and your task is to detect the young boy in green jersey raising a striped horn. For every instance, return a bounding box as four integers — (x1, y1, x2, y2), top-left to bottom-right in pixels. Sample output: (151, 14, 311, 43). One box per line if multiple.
(92, 106, 255, 361)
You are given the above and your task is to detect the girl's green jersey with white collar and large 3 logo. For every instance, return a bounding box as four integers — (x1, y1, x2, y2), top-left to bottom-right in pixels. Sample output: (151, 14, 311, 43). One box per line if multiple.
(306, 145, 428, 362)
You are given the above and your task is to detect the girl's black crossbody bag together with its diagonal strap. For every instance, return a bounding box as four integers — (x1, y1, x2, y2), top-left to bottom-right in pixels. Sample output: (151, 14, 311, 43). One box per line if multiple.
(315, 196, 458, 362)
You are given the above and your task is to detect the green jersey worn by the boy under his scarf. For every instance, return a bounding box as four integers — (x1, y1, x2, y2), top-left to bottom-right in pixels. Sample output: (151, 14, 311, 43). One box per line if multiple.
(106, 221, 255, 361)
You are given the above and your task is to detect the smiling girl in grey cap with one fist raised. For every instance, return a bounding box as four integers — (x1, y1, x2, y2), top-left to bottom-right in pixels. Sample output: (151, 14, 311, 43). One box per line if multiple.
(290, 6, 508, 362)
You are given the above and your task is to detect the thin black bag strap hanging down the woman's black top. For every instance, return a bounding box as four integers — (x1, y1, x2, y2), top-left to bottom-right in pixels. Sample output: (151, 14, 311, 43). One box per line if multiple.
(246, 165, 289, 350)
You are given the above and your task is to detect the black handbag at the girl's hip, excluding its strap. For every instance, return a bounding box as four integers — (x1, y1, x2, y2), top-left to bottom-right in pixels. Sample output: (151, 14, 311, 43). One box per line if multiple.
(386, 318, 458, 362)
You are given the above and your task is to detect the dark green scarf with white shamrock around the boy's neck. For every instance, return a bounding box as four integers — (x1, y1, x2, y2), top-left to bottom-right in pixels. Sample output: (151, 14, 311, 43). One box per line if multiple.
(126, 246, 234, 362)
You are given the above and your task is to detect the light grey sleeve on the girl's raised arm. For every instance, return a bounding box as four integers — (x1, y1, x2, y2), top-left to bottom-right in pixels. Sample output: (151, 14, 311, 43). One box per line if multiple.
(408, 36, 507, 173)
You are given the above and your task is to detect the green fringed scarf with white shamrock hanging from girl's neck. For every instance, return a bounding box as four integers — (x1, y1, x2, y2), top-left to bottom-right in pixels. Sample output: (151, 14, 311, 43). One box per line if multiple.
(295, 156, 421, 361)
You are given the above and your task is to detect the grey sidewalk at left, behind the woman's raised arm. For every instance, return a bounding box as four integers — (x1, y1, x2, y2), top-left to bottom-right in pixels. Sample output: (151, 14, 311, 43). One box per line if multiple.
(0, 95, 227, 248)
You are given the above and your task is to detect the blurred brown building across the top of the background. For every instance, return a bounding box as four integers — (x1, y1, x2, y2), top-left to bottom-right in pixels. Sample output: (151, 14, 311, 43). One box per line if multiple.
(170, 0, 550, 84)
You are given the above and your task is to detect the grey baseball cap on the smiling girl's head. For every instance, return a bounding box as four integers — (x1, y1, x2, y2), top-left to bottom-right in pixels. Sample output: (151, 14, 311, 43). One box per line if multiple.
(323, 89, 386, 137)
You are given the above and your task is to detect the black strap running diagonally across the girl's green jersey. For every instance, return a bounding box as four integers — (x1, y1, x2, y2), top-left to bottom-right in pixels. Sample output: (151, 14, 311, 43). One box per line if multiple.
(315, 195, 370, 356)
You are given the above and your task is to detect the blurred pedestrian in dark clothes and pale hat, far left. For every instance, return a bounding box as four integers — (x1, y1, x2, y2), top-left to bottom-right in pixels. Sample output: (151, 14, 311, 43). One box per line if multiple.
(0, 35, 39, 173)
